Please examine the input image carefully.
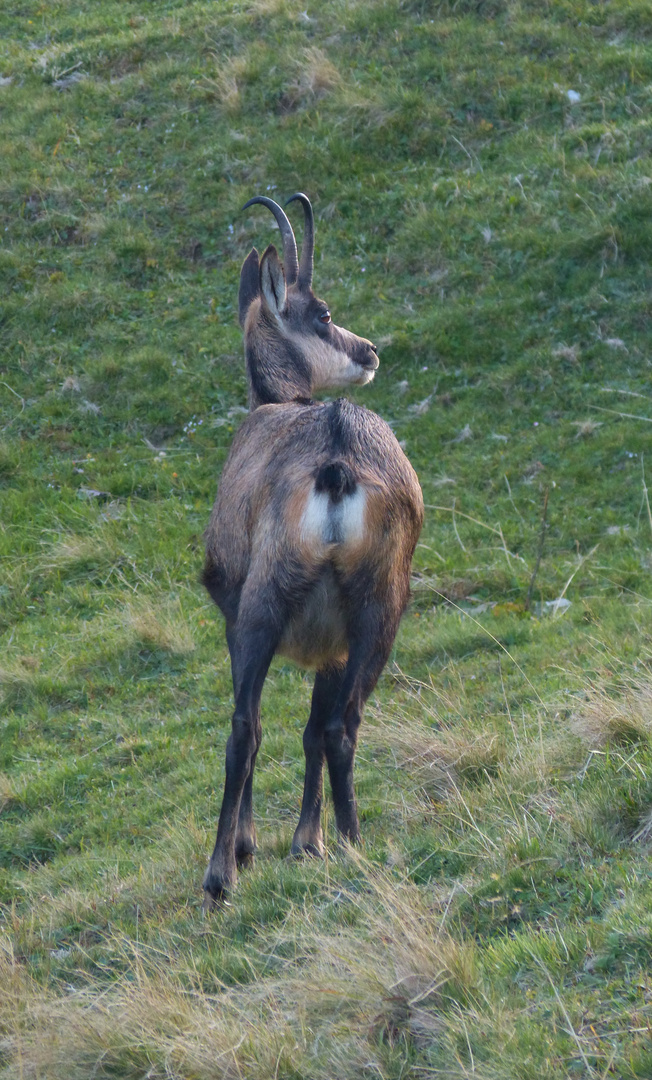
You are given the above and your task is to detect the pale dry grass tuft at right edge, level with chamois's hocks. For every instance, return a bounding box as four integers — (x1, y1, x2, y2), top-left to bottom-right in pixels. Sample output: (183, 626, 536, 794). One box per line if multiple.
(571, 675, 652, 750)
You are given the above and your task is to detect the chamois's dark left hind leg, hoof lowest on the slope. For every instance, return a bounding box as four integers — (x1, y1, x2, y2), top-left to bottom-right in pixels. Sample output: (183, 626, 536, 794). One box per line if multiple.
(204, 613, 280, 910)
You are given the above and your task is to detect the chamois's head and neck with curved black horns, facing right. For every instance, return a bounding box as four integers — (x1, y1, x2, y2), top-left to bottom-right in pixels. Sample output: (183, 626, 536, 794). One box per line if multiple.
(239, 192, 378, 408)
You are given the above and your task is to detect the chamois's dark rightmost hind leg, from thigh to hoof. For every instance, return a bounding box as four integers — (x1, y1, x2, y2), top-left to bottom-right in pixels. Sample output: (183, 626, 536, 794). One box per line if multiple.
(324, 599, 403, 843)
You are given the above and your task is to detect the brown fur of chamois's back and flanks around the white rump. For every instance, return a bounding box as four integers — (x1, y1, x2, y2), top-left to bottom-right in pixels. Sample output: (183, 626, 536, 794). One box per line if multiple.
(206, 404, 422, 666)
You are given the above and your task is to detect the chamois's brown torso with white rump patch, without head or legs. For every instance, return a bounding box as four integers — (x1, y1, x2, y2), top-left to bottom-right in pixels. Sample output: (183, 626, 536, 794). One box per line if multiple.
(204, 399, 420, 669)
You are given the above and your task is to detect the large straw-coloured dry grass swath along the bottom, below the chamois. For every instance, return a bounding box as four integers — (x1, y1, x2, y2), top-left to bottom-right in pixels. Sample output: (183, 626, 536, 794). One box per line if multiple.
(0, 853, 478, 1080)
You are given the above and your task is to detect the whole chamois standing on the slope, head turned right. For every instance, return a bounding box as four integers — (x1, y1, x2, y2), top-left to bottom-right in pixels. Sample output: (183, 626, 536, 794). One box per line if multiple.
(203, 193, 423, 910)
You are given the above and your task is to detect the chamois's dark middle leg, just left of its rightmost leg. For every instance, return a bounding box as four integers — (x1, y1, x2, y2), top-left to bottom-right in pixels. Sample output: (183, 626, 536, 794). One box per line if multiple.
(291, 667, 344, 856)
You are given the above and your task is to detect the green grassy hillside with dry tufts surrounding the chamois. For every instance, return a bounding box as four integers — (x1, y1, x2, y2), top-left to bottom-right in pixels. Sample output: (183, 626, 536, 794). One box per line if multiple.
(0, 0, 652, 1080)
